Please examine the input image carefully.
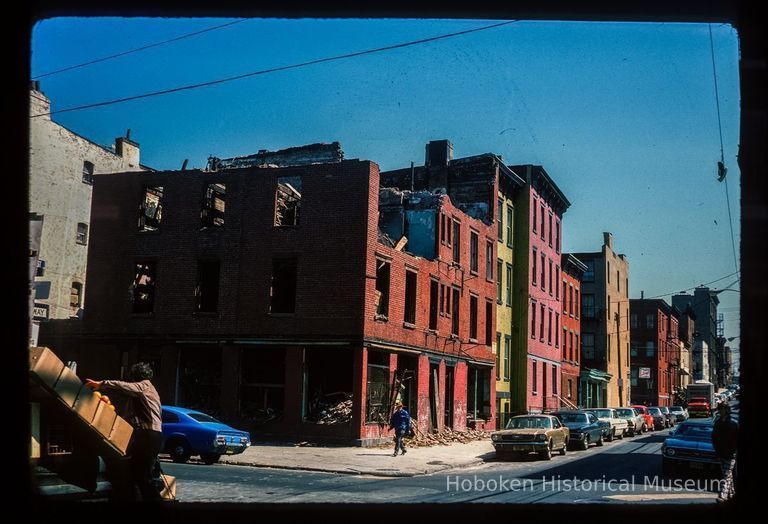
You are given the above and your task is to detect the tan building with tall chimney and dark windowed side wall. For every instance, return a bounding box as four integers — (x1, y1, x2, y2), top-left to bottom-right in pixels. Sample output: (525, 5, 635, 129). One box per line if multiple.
(574, 232, 631, 407)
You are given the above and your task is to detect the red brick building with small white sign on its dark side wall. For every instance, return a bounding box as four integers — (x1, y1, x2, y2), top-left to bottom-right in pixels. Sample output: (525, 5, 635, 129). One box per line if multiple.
(629, 299, 680, 406)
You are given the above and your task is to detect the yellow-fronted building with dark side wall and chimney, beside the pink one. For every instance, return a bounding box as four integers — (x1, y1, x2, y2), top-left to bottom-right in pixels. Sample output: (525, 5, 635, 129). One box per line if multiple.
(381, 140, 524, 426)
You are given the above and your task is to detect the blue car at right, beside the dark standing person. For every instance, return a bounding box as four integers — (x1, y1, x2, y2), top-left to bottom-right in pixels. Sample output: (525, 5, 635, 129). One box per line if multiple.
(661, 419, 720, 475)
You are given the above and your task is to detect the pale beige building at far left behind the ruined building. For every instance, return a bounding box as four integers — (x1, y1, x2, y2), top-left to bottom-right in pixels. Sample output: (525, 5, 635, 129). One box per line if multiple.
(29, 82, 147, 320)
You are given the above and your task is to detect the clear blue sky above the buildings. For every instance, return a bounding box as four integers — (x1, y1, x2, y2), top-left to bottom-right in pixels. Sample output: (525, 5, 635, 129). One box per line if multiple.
(31, 18, 741, 358)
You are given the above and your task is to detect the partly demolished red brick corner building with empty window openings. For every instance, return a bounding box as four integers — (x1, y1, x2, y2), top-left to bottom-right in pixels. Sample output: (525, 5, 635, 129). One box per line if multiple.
(58, 149, 496, 444)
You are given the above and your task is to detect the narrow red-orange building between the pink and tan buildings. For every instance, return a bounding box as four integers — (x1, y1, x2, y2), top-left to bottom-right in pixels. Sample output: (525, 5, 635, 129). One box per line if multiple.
(560, 253, 587, 408)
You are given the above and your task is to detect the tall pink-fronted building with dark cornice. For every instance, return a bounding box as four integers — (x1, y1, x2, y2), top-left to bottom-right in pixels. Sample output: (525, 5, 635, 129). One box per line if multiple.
(509, 165, 571, 413)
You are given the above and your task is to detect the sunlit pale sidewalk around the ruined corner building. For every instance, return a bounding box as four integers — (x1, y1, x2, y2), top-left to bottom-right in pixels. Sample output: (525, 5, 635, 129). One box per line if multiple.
(220, 439, 495, 477)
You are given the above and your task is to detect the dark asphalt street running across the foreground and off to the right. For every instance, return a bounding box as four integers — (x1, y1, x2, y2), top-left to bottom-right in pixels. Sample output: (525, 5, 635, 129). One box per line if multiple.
(163, 422, 728, 504)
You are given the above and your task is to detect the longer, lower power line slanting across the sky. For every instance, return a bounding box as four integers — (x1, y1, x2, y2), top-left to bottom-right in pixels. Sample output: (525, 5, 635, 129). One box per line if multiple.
(30, 20, 518, 118)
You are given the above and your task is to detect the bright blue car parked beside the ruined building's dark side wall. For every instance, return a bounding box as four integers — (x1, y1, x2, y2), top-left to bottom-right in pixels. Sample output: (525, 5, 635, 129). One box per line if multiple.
(162, 406, 251, 464)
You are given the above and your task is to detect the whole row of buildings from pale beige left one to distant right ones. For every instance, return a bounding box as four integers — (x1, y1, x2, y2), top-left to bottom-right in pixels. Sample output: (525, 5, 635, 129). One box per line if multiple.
(30, 86, 736, 444)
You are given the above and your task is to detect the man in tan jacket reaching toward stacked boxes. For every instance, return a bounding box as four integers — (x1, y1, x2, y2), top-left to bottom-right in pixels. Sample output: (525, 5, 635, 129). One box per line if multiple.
(85, 362, 162, 500)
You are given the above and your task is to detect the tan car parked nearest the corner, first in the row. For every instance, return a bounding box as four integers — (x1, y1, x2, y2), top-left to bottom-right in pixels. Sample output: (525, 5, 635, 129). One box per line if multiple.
(491, 415, 570, 460)
